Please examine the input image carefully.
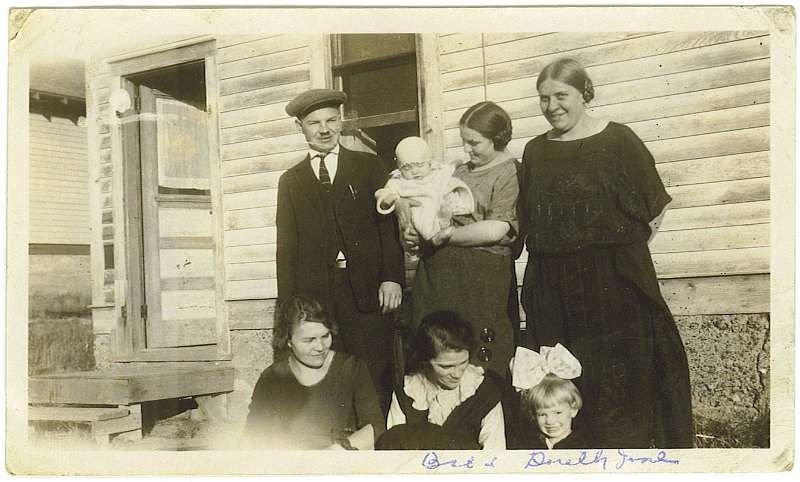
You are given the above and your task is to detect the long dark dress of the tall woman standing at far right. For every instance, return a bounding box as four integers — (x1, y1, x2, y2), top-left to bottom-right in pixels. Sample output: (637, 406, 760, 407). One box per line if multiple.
(519, 122, 693, 448)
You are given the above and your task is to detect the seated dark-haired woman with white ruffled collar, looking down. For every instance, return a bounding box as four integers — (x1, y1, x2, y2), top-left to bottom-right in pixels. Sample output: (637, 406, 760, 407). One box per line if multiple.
(376, 311, 510, 450)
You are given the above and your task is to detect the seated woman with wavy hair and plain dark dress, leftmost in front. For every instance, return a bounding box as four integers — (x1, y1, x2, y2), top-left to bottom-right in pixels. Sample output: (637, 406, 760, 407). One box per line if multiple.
(245, 296, 386, 450)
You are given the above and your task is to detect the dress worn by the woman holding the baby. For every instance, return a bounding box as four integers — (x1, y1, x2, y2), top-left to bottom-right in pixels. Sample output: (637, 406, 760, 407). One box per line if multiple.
(411, 159, 519, 375)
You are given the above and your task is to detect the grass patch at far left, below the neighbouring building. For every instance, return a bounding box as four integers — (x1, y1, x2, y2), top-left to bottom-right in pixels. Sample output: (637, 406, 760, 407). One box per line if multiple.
(28, 317, 95, 375)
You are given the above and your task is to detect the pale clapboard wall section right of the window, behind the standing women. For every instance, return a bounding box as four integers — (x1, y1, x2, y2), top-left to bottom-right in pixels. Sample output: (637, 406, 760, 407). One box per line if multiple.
(439, 32, 770, 314)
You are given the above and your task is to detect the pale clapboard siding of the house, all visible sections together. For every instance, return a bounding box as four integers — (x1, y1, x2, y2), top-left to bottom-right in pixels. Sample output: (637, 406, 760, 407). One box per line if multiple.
(87, 32, 770, 338)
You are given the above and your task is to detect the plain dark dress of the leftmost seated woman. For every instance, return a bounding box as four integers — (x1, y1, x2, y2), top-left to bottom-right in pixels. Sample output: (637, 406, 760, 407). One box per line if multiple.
(245, 352, 386, 450)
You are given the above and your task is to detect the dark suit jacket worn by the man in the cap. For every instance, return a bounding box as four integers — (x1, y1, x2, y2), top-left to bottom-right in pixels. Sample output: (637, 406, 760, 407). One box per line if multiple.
(276, 146, 405, 312)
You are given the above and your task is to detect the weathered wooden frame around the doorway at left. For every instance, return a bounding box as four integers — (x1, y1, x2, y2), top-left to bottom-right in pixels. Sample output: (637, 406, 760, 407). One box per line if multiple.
(107, 37, 231, 361)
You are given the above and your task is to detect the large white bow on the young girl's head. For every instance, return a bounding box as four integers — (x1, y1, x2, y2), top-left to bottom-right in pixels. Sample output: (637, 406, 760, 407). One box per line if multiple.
(511, 343, 581, 390)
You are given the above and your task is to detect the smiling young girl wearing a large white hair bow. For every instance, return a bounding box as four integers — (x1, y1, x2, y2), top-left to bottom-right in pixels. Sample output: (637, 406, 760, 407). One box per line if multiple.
(511, 343, 592, 449)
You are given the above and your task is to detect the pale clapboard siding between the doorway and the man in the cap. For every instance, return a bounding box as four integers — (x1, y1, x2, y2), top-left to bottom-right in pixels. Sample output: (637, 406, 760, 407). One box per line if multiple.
(219, 35, 312, 300)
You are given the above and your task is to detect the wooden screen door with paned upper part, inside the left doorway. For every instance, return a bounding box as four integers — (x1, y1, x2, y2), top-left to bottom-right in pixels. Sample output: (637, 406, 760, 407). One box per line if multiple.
(136, 68, 220, 349)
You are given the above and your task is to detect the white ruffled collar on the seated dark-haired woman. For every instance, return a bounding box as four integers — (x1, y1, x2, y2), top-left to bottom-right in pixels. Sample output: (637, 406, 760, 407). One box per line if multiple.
(403, 364, 484, 425)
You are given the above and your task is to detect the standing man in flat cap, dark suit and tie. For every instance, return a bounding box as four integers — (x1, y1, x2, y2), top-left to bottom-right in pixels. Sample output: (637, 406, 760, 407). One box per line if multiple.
(276, 89, 405, 413)
